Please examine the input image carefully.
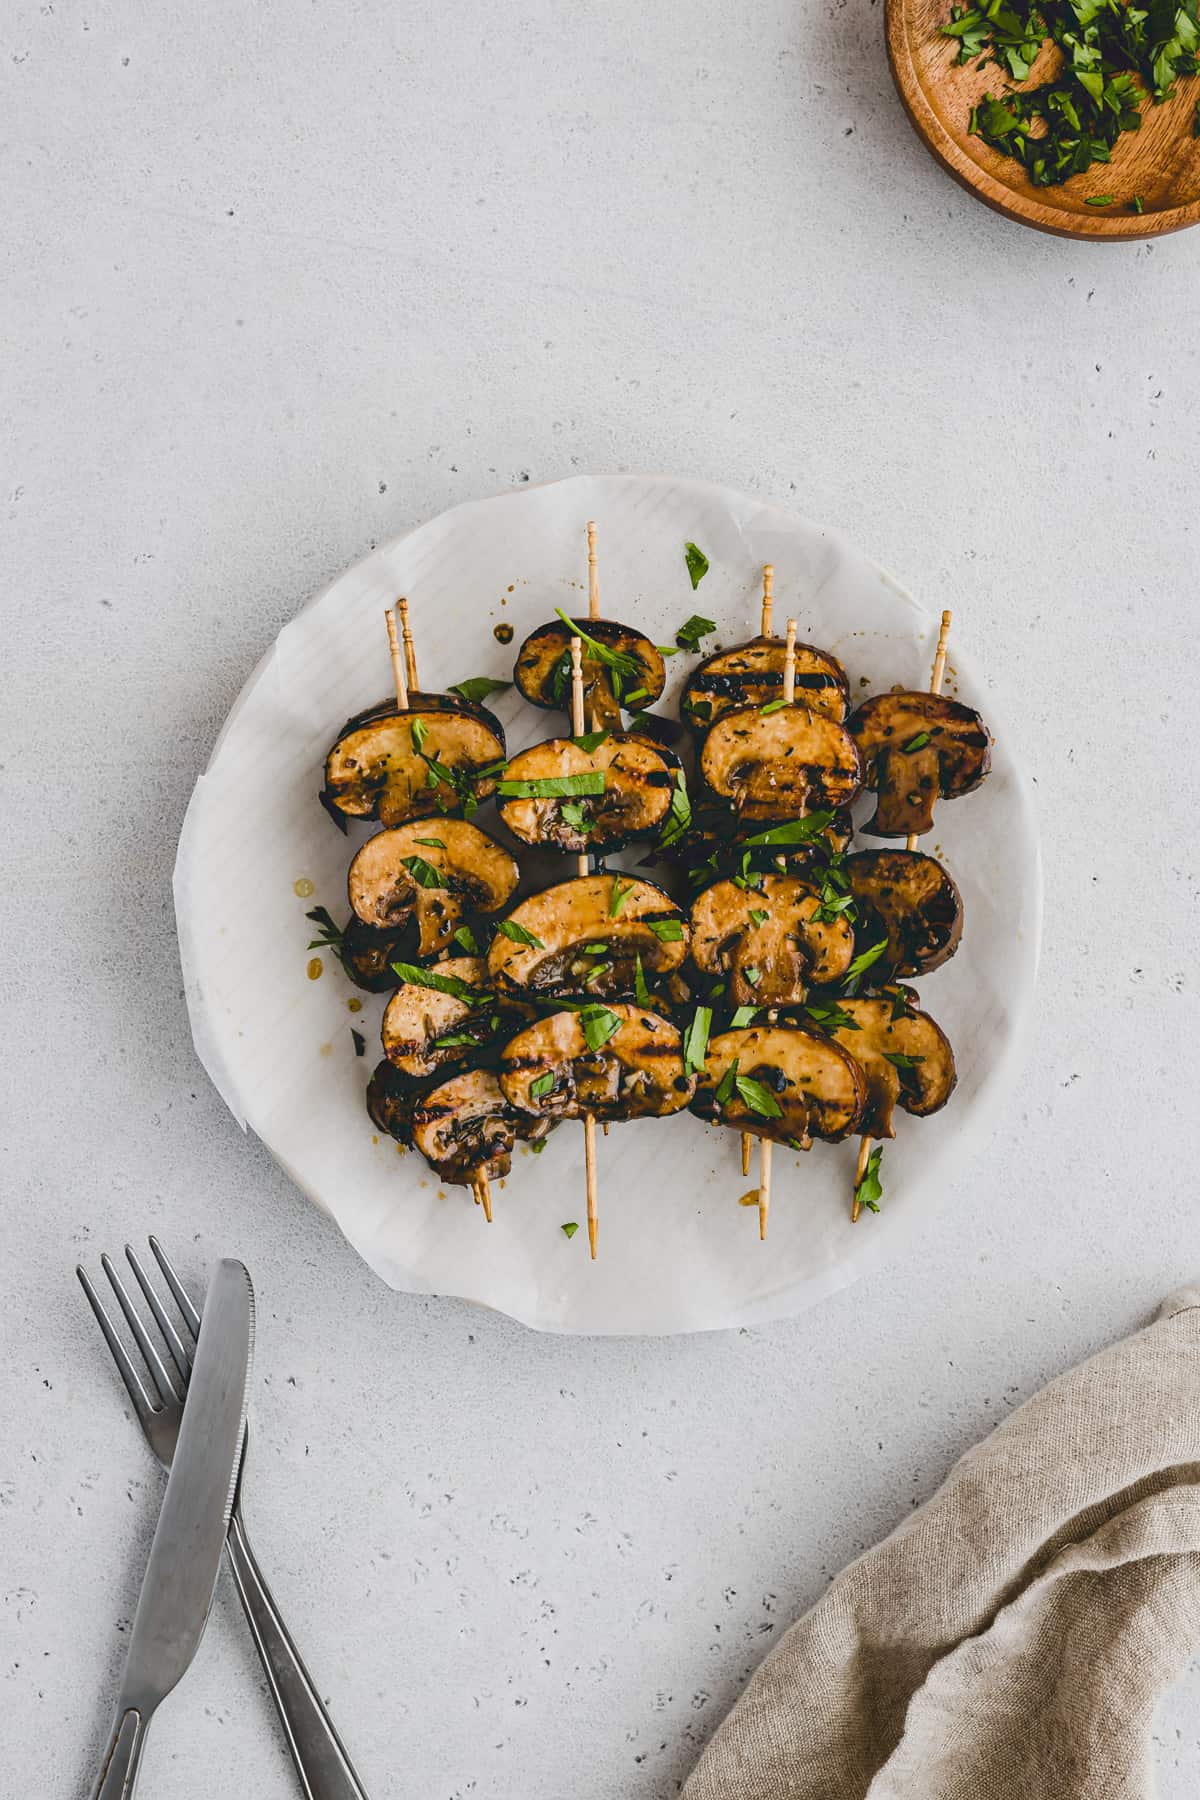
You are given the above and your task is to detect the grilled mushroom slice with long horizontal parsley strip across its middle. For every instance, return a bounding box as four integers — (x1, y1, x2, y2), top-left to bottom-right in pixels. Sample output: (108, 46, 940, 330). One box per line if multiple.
(498, 731, 678, 851)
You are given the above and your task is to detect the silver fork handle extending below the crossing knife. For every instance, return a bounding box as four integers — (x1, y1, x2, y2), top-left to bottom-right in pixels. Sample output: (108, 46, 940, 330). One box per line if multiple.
(226, 1507, 367, 1800)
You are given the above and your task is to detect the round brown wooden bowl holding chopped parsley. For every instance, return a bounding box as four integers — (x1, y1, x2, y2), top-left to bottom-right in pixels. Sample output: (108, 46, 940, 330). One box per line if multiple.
(887, 0, 1200, 241)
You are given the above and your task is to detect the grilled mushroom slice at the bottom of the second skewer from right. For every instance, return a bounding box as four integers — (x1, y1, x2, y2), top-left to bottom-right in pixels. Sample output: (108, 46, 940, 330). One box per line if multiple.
(693, 1024, 867, 1147)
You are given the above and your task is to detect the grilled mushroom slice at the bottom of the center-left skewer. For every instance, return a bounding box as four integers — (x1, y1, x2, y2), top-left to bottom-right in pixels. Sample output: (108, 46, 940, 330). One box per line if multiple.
(500, 1003, 696, 1120)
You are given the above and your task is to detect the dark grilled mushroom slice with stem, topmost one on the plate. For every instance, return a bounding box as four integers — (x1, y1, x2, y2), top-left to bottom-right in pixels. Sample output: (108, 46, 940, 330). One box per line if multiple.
(513, 619, 667, 731)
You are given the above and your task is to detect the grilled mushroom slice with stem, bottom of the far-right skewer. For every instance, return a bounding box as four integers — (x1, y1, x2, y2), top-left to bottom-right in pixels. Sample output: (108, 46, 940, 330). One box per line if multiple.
(831, 988, 957, 1138)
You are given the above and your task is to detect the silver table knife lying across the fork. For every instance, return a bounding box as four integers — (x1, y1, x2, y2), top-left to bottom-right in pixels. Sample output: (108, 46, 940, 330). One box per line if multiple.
(94, 1258, 254, 1800)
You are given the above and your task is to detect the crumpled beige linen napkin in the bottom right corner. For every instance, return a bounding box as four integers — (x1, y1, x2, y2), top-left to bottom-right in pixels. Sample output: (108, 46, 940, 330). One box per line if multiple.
(684, 1289, 1200, 1800)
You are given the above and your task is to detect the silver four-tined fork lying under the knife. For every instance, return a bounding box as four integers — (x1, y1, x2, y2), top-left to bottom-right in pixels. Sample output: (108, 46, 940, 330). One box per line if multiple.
(76, 1237, 367, 1800)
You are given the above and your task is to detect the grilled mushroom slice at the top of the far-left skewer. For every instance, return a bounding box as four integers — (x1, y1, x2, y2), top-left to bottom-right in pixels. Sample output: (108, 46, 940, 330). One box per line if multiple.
(320, 693, 504, 824)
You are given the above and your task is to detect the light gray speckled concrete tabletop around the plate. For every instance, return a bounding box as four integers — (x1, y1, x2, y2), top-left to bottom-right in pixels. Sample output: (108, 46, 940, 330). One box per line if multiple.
(0, 0, 1200, 1800)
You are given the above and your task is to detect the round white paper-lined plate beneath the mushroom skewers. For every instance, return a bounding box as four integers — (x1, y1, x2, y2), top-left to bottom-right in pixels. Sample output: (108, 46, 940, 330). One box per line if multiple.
(175, 475, 1042, 1332)
